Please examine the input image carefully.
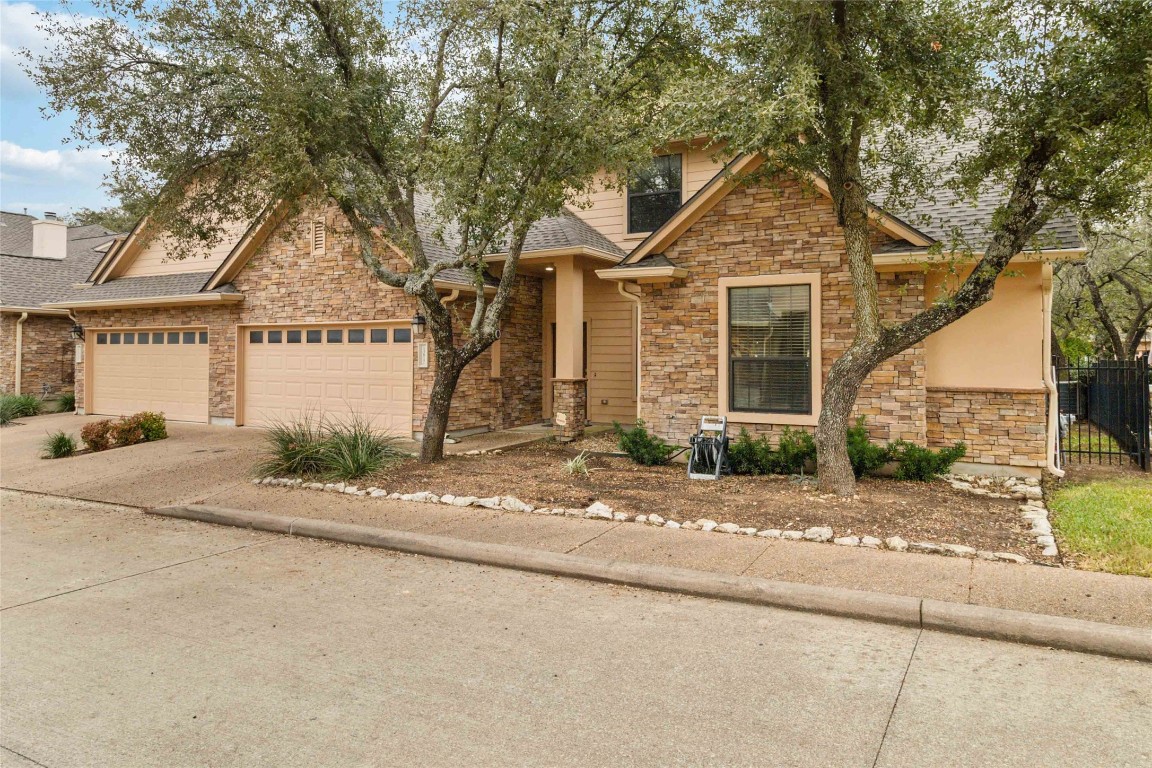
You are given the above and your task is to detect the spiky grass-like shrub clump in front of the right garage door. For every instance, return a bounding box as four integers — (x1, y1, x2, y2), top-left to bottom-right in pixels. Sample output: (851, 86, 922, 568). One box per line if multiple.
(256, 413, 403, 480)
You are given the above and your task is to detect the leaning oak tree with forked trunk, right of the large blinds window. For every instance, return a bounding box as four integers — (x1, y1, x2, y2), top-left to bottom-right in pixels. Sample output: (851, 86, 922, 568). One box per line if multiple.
(667, 0, 1152, 495)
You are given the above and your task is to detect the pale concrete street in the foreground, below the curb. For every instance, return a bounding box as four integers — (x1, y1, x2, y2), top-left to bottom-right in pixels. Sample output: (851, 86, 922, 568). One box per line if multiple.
(0, 492, 1152, 768)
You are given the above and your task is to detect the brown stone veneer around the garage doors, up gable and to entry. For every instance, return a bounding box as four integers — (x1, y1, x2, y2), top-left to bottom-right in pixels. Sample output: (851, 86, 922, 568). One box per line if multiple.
(76, 206, 540, 432)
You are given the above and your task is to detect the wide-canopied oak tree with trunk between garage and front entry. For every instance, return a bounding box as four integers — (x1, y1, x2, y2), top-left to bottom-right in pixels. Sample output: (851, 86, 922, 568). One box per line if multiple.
(32, 0, 691, 461)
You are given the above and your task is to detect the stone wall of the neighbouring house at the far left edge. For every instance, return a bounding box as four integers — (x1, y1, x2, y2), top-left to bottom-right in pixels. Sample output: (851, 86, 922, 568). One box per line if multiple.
(0, 314, 74, 395)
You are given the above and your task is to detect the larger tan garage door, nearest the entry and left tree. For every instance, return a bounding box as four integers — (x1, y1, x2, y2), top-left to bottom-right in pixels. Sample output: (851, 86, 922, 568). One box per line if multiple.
(243, 325, 412, 436)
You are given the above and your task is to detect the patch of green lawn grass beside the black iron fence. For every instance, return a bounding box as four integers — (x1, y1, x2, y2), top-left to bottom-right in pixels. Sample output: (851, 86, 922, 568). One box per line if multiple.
(1048, 476, 1152, 577)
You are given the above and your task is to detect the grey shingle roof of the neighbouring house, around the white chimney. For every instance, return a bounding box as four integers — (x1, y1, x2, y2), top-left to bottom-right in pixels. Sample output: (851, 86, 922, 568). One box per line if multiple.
(0, 212, 116, 309)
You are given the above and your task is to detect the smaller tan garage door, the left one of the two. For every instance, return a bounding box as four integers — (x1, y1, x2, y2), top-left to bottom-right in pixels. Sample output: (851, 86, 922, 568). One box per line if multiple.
(91, 328, 209, 421)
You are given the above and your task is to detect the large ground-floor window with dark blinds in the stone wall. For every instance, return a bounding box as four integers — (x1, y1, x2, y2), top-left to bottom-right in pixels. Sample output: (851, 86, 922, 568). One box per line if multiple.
(728, 286, 812, 415)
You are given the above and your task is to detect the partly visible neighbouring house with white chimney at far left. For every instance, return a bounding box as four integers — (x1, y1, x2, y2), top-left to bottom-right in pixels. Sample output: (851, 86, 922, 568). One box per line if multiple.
(0, 212, 115, 396)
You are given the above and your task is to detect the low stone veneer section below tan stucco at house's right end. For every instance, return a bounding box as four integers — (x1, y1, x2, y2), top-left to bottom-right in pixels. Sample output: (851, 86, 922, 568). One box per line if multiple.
(927, 387, 1048, 466)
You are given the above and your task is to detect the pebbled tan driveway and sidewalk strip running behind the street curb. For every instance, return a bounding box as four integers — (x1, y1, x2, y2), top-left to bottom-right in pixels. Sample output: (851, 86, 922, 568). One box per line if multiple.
(0, 416, 1152, 628)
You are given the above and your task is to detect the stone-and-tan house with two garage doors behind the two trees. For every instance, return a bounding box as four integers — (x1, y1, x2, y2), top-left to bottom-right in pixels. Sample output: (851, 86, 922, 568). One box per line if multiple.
(36, 138, 1083, 472)
